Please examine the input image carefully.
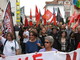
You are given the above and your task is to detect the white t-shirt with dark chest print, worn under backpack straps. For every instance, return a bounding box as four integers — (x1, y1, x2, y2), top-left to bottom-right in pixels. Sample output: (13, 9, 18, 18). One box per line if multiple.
(1, 37, 19, 56)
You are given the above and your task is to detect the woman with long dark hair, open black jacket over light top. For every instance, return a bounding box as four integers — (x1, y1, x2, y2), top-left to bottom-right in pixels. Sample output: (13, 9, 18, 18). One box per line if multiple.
(58, 31, 68, 52)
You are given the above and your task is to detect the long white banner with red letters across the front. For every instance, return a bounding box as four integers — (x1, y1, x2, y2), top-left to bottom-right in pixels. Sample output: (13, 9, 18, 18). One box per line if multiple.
(0, 49, 80, 60)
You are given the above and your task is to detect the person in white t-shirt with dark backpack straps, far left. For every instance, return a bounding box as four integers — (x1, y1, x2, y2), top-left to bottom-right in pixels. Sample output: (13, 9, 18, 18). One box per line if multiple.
(0, 32, 19, 56)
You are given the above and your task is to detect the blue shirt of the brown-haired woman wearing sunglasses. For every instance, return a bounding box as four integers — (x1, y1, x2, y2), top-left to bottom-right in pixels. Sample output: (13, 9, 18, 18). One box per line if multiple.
(26, 40, 41, 53)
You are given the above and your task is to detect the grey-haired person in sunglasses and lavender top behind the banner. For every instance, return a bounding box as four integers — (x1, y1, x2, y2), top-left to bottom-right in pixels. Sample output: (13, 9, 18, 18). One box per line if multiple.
(39, 36, 58, 52)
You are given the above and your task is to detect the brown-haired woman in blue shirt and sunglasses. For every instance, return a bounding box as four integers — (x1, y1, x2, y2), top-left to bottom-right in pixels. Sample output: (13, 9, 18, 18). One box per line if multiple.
(25, 31, 41, 53)
